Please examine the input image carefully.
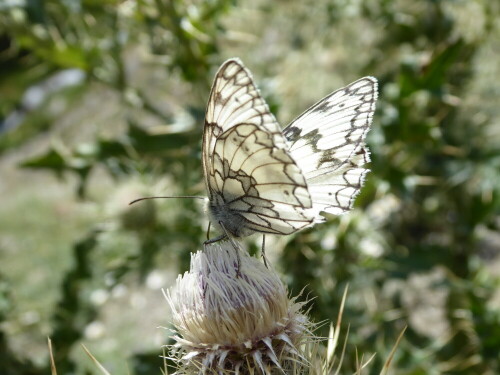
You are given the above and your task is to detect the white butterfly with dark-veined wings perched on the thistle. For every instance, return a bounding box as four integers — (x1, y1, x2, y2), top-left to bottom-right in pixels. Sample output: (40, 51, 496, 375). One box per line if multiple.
(202, 58, 377, 240)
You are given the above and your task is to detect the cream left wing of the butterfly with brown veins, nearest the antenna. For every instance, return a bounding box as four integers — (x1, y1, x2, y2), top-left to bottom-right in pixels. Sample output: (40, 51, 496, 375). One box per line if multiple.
(202, 59, 314, 237)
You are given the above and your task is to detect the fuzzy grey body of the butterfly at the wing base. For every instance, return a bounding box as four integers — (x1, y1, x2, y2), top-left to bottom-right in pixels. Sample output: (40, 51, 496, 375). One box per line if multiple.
(205, 194, 255, 237)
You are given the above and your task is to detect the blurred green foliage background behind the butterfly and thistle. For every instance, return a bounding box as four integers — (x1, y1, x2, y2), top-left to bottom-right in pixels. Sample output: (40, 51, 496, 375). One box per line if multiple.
(0, 0, 500, 375)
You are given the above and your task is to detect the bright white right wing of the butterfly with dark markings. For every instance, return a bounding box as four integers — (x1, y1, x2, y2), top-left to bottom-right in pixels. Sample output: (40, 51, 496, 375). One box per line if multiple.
(283, 77, 377, 222)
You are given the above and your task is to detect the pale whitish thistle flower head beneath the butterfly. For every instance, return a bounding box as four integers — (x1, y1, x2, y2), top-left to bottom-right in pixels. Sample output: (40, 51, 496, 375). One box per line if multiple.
(167, 243, 310, 374)
